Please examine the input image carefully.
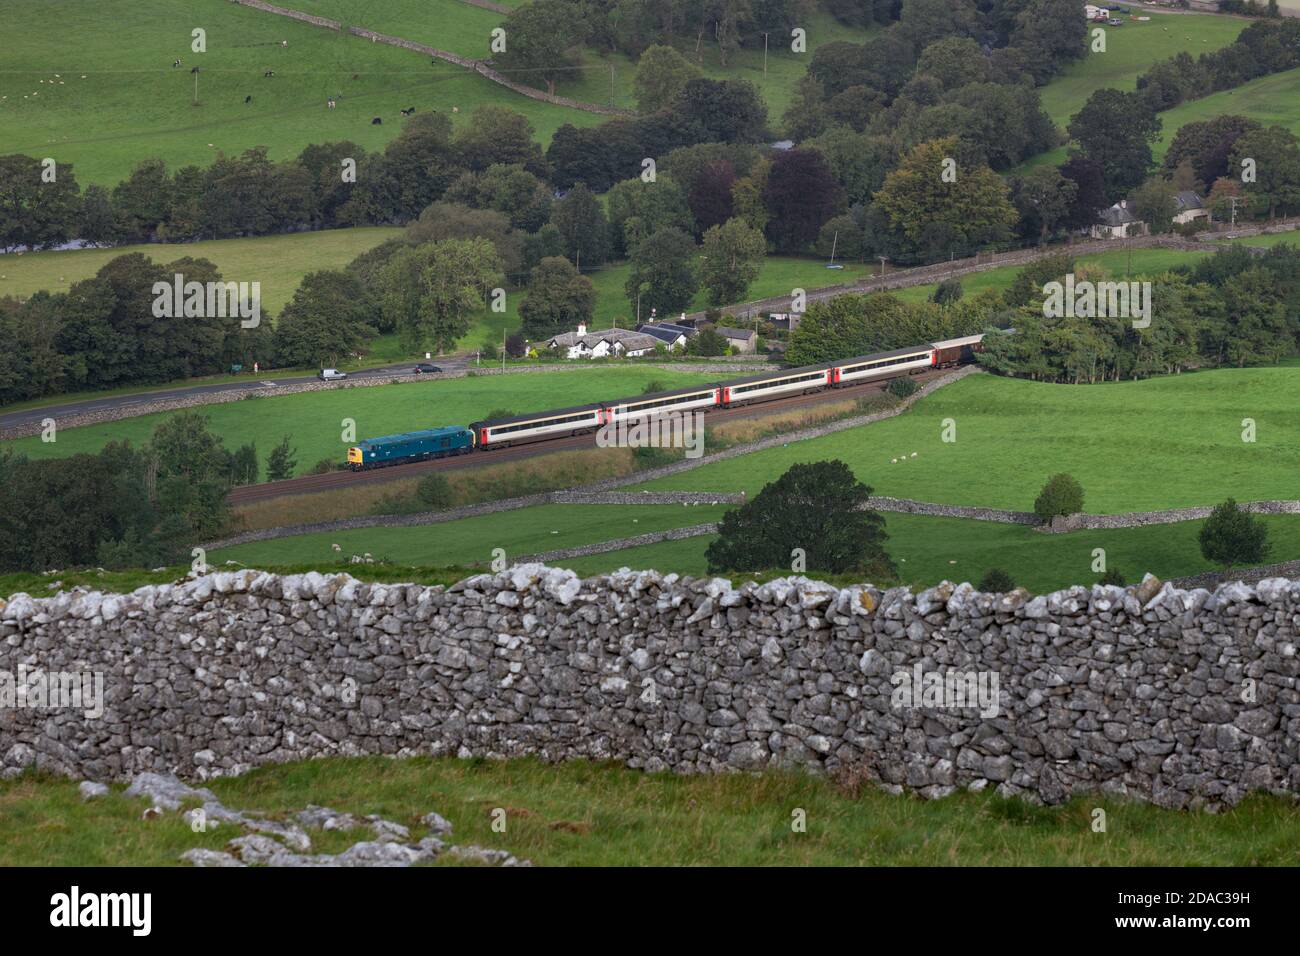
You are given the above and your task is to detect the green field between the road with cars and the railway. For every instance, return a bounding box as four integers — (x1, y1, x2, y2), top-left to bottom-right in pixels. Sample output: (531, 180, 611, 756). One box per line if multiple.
(12, 365, 718, 473)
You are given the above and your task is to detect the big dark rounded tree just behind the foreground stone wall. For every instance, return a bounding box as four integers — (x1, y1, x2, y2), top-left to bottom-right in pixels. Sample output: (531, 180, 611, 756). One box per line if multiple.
(705, 460, 896, 578)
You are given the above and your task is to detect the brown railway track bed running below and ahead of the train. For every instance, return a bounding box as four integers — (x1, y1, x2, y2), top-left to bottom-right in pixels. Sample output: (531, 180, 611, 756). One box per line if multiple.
(229, 369, 946, 506)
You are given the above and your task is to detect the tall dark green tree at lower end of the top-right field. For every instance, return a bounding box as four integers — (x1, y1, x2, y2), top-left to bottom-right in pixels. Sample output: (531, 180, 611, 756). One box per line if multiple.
(1067, 87, 1160, 202)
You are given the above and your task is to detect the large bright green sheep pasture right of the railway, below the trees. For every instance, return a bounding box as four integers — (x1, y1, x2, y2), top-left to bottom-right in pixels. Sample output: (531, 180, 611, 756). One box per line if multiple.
(644, 368, 1300, 514)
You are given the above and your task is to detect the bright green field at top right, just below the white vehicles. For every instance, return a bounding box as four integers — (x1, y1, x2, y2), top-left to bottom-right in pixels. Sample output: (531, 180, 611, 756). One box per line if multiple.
(1040, 7, 1248, 130)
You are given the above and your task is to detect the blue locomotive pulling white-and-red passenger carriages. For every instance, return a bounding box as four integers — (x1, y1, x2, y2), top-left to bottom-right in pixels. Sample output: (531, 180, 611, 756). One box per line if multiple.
(347, 334, 984, 471)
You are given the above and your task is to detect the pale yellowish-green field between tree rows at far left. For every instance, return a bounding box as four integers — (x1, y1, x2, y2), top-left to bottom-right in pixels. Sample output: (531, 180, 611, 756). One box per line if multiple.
(0, 226, 402, 315)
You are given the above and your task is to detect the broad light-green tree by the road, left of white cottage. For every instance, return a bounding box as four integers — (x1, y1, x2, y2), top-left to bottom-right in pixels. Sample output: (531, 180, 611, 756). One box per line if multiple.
(382, 238, 504, 351)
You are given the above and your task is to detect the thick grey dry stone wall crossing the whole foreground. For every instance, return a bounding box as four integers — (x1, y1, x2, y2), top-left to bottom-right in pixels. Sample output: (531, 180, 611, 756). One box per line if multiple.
(0, 564, 1300, 808)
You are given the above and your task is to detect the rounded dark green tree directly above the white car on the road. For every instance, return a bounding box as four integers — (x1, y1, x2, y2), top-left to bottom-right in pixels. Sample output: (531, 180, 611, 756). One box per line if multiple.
(276, 269, 377, 368)
